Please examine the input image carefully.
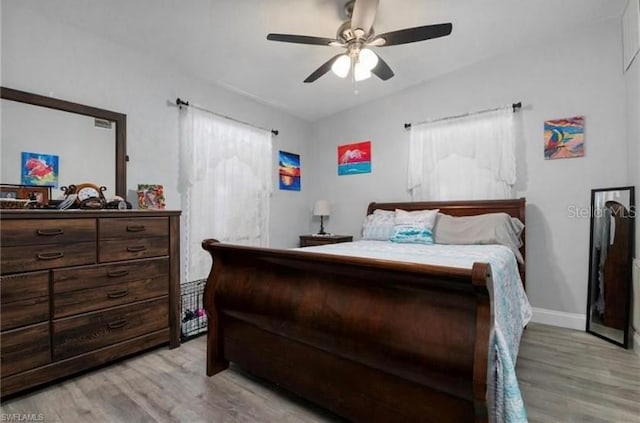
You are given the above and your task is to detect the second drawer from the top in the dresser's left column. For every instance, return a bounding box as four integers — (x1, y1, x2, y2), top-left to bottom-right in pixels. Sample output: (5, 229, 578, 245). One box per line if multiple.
(1, 242, 96, 274)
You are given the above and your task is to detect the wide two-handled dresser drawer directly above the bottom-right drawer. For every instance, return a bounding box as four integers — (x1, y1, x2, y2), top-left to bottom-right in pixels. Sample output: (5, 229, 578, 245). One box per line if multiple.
(53, 259, 169, 318)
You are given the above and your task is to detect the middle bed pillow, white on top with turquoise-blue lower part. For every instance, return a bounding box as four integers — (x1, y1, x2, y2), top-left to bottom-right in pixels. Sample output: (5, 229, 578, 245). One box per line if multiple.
(391, 209, 439, 244)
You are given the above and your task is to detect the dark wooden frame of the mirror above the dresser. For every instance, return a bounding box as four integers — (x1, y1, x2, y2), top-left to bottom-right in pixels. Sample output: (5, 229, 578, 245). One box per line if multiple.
(0, 87, 128, 200)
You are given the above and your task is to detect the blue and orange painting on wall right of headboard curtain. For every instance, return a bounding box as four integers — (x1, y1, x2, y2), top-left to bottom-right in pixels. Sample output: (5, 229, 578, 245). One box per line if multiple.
(544, 116, 584, 160)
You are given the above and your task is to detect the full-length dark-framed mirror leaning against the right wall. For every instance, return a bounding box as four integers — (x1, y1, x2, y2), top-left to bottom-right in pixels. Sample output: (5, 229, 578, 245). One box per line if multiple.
(587, 187, 635, 348)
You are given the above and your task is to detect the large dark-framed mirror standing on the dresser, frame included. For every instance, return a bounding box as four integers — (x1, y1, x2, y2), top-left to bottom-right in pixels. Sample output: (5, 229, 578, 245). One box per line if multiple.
(0, 87, 127, 198)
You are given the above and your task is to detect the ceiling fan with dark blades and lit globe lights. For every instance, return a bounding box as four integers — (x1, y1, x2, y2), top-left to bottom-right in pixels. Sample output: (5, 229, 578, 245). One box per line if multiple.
(267, 0, 453, 82)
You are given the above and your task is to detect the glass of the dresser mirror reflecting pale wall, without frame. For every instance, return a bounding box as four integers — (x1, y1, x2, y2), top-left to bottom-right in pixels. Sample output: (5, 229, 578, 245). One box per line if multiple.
(0, 99, 116, 198)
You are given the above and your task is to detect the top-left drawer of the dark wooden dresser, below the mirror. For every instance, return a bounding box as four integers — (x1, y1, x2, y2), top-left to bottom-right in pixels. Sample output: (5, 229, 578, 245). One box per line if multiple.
(0, 219, 96, 248)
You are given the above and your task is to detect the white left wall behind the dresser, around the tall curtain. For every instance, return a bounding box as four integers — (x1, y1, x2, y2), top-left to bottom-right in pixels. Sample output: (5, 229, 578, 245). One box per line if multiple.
(1, 1, 311, 247)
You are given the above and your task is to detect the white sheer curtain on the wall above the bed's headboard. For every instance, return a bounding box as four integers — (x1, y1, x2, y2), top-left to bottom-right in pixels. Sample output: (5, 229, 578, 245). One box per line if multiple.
(408, 108, 516, 201)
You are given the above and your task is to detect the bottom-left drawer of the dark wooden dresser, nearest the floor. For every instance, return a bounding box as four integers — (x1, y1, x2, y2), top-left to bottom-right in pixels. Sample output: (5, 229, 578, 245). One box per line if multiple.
(0, 322, 51, 377)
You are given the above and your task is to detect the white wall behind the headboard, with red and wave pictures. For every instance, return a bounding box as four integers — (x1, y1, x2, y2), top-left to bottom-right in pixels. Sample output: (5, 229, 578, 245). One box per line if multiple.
(312, 20, 627, 320)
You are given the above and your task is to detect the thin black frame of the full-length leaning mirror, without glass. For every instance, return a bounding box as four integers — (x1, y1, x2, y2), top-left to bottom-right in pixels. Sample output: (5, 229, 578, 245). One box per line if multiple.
(586, 186, 636, 349)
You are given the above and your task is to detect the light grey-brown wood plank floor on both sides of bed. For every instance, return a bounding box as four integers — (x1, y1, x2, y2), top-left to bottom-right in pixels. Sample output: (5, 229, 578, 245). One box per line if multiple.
(0, 324, 640, 423)
